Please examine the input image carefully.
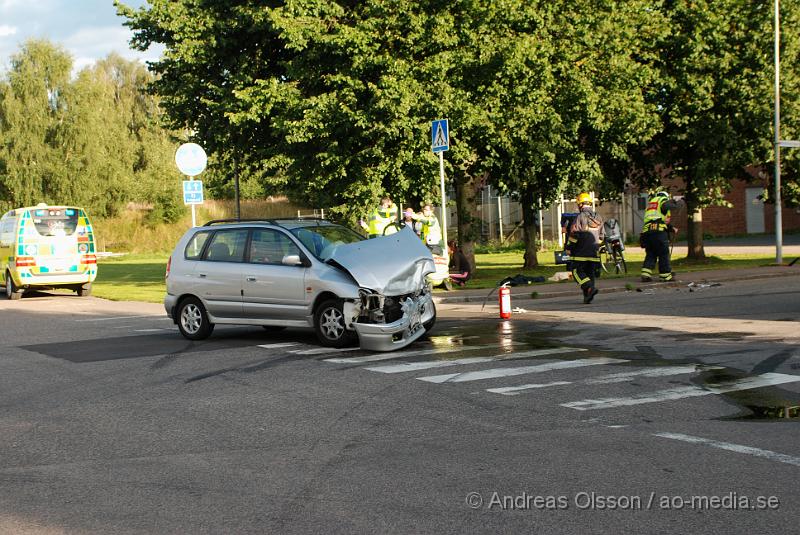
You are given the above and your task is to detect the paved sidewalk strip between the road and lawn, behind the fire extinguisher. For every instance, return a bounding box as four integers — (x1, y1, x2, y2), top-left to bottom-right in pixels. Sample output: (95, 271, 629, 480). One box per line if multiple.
(433, 262, 800, 305)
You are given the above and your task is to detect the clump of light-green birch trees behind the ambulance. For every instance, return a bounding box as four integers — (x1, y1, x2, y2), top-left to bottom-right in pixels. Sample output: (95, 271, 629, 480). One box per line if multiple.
(0, 40, 180, 216)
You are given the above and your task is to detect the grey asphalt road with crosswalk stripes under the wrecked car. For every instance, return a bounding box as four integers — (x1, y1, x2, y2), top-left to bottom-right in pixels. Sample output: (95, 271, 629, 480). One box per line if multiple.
(0, 277, 800, 535)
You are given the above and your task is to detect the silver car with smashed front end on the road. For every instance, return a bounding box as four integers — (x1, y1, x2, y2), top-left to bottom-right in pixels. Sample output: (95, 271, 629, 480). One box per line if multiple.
(164, 219, 436, 351)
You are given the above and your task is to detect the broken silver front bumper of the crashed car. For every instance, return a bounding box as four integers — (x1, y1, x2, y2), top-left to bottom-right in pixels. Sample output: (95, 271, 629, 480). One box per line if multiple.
(353, 293, 435, 351)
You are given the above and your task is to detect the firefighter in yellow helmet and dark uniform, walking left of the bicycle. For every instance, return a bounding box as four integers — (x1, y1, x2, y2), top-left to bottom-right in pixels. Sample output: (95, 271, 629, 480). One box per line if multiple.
(564, 193, 604, 304)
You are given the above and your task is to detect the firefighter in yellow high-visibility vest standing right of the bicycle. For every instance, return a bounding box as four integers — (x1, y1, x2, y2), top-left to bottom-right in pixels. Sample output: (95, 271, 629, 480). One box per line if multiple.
(639, 191, 675, 282)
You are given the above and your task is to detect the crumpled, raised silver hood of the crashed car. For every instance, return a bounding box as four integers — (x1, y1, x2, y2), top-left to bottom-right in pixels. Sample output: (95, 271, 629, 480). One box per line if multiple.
(329, 227, 436, 296)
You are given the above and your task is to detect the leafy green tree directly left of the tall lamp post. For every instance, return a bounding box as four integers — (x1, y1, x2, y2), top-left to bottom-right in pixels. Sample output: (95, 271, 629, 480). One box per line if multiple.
(632, 0, 784, 259)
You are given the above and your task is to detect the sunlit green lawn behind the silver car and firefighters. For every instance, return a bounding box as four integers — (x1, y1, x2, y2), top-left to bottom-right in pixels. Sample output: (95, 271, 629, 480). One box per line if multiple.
(92, 251, 774, 303)
